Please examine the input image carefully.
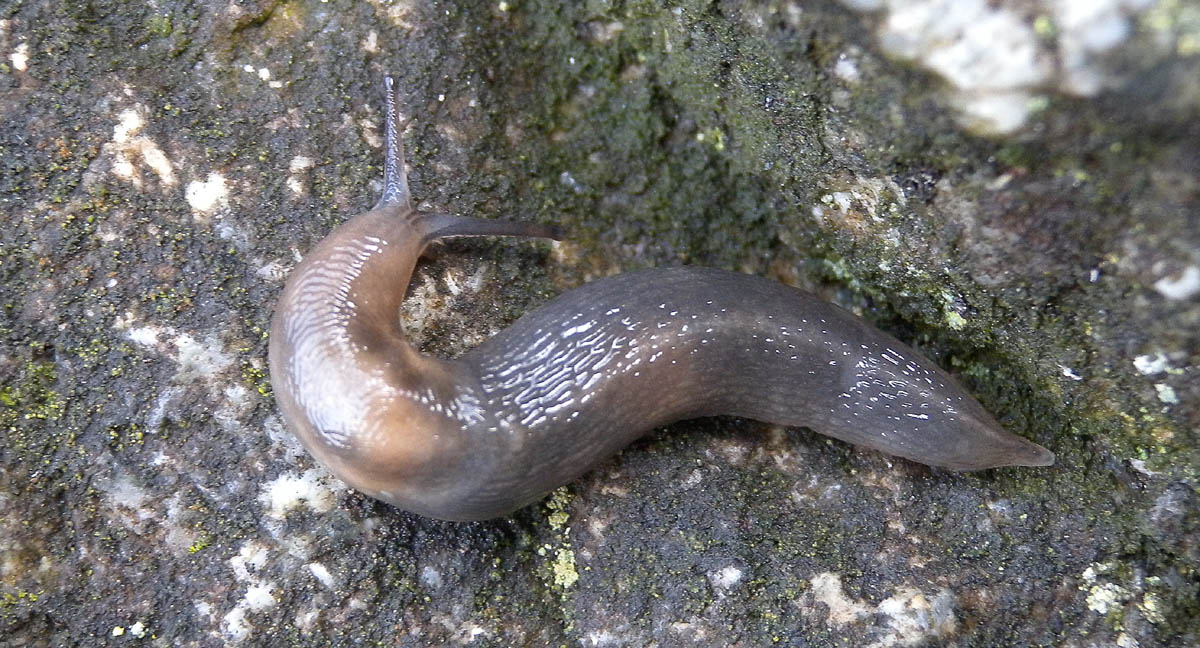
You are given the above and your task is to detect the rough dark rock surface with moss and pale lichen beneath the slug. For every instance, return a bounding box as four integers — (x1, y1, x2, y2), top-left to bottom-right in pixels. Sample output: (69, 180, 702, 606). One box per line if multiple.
(0, 0, 1200, 647)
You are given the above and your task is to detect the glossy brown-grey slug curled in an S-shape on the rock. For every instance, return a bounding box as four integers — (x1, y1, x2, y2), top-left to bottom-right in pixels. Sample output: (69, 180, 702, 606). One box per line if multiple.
(269, 77, 1055, 521)
